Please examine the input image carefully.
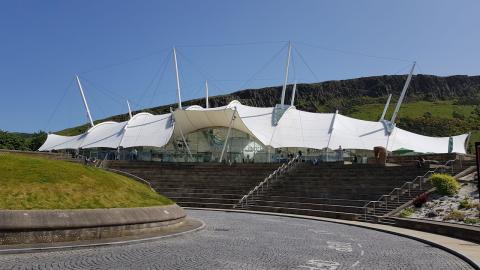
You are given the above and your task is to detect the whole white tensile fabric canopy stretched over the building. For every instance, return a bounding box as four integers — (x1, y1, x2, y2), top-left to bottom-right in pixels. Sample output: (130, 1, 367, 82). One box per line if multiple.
(39, 101, 468, 154)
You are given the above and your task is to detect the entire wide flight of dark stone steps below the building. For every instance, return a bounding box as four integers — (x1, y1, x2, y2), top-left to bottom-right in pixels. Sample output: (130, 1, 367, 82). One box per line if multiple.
(108, 161, 468, 223)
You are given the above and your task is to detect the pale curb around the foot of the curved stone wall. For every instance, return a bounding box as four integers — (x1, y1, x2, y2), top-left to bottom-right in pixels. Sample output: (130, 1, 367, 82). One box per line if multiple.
(0, 218, 206, 255)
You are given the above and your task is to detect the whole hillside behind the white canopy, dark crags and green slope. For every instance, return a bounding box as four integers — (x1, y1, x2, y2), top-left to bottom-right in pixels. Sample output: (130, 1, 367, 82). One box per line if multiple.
(57, 74, 480, 152)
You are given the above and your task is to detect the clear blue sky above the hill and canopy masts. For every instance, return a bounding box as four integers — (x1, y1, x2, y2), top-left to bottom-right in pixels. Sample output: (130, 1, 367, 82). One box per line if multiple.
(0, 0, 480, 132)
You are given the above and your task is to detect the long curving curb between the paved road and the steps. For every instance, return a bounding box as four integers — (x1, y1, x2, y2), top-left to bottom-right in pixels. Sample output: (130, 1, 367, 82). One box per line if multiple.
(184, 207, 480, 270)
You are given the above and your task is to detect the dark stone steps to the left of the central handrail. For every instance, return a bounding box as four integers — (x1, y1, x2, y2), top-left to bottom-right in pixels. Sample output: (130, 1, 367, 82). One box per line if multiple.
(107, 161, 280, 209)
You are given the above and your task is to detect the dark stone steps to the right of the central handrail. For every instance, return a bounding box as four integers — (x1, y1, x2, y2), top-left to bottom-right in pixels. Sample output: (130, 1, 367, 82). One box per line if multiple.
(246, 164, 426, 220)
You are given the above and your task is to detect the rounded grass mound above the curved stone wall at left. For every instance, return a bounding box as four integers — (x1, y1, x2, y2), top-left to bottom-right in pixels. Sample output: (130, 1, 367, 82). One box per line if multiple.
(0, 153, 173, 209)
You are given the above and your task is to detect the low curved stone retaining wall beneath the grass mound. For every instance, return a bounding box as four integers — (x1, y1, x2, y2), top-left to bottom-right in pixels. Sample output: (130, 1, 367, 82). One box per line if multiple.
(0, 204, 186, 245)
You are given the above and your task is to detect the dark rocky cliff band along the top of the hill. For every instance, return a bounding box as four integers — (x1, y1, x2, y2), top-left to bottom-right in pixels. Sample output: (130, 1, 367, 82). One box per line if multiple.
(57, 74, 480, 135)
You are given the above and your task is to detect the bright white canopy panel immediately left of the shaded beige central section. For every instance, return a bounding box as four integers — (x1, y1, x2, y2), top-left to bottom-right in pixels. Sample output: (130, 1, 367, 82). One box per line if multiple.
(120, 113, 174, 148)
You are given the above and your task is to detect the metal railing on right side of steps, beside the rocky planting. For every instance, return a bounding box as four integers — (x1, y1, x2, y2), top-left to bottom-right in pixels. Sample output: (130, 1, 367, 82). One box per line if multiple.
(363, 160, 455, 220)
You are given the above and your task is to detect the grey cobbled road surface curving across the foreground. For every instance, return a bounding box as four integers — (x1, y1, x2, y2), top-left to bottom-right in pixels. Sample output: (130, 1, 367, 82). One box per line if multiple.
(0, 210, 473, 270)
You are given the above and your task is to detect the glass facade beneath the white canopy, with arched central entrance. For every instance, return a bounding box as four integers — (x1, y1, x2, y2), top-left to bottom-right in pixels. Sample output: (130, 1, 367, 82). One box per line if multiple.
(66, 127, 376, 163)
